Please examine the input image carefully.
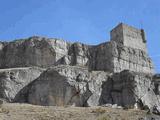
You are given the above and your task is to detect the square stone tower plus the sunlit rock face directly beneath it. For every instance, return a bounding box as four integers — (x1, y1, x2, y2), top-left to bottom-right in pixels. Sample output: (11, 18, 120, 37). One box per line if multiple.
(110, 23, 154, 73)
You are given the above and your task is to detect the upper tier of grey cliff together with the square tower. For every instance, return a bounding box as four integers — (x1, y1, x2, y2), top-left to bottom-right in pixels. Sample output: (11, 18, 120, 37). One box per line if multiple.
(0, 23, 154, 73)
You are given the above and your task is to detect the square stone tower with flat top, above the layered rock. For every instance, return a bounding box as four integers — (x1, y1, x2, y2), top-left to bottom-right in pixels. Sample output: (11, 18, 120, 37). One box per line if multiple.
(110, 23, 147, 52)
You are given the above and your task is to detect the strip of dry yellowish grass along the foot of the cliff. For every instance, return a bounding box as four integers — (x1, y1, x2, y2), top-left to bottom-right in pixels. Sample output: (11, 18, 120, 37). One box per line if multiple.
(0, 104, 160, 120)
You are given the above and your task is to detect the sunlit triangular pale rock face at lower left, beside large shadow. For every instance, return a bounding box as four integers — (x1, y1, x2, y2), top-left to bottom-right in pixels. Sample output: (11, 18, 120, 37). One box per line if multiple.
(0, 67, 43, 102)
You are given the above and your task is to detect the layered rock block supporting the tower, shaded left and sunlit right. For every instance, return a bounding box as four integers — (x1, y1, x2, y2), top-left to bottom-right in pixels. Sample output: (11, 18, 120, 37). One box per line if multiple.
(89, 41, 154, 74)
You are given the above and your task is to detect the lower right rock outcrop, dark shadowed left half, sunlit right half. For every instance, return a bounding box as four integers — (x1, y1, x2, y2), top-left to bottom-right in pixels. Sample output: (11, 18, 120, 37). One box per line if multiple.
(101, 71, 160, 108)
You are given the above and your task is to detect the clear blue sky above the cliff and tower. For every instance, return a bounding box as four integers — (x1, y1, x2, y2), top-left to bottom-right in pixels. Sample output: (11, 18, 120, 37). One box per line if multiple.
(0, 0, 160, 73)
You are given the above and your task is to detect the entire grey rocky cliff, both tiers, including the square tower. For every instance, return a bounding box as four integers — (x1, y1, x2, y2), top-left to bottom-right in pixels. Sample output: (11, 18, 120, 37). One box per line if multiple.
(0, 24, 160, 113)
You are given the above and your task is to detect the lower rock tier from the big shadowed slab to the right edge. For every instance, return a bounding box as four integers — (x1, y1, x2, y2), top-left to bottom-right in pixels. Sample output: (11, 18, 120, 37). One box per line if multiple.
(14, 68, 159, 109)
